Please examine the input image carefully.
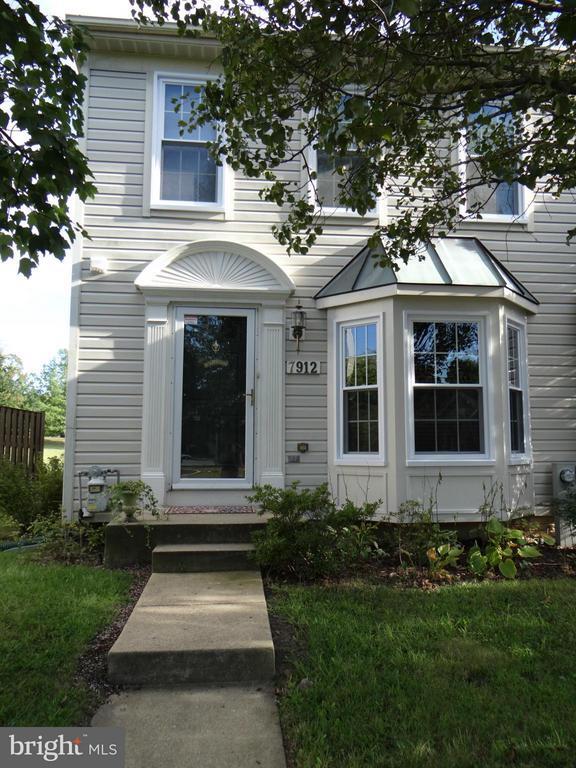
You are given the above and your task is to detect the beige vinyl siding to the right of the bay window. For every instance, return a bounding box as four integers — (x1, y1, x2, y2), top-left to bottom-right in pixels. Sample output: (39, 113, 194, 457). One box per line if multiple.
(462, 204, 576, 503)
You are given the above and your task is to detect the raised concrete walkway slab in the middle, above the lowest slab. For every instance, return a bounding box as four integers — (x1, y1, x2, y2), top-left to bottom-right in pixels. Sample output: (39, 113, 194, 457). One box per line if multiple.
(108, 571, 274, 686)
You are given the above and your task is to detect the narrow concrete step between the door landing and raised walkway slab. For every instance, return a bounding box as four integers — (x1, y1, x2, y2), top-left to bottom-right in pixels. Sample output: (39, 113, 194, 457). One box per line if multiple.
(152, 544, 254, 573)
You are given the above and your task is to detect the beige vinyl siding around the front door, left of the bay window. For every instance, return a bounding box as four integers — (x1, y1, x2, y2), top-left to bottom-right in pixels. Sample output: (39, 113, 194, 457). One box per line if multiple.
(74, 55, 369, 504)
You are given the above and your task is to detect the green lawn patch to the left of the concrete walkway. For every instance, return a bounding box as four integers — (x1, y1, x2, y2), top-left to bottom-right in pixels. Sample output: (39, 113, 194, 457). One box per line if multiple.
(0, 552, 131, 726)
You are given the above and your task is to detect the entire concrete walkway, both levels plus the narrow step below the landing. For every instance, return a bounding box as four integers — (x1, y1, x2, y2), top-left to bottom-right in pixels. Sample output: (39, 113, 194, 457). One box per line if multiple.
(92, 552, 286, 768)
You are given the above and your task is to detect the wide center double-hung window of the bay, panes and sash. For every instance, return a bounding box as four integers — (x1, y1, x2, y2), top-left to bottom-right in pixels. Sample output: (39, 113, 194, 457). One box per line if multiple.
(411, 319, 485, 457)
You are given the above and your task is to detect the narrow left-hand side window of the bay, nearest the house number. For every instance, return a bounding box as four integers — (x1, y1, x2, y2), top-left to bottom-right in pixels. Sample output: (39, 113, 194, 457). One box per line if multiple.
(339, 321, 381, 456)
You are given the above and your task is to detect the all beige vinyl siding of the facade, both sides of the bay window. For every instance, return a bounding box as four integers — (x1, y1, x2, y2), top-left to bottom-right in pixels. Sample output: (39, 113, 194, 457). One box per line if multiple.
(74, 54, 576, 510)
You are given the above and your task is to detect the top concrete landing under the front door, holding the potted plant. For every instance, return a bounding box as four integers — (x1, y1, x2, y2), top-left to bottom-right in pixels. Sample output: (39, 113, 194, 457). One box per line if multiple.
(104, 514, 266, 568)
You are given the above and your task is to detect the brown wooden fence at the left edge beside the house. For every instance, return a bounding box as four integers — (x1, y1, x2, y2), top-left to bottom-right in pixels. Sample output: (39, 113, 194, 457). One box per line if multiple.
(0, 405, 44, 471)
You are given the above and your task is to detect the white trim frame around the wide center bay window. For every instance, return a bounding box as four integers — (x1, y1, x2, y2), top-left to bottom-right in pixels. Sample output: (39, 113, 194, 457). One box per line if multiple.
(404, 312, 495, 467)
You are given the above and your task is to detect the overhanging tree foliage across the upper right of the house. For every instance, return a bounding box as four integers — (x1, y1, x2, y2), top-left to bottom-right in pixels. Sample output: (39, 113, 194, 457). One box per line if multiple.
(132, 0, 576, 268)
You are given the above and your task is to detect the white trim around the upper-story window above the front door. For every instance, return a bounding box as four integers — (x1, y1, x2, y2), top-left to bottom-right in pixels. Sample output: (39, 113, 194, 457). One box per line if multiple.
(150, 72, 228, 212)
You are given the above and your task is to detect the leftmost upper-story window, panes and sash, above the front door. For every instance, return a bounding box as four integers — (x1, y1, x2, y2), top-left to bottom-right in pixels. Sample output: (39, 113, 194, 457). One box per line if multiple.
(151, 76, 223, 209)
